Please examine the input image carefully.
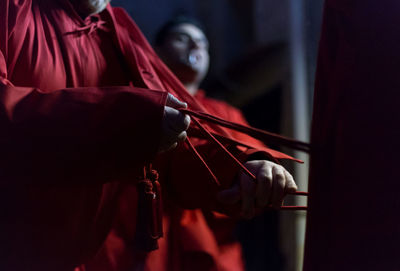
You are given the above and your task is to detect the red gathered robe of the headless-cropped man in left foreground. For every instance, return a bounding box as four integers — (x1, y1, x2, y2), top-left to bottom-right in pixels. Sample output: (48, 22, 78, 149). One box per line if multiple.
(0, 0, 166, 271)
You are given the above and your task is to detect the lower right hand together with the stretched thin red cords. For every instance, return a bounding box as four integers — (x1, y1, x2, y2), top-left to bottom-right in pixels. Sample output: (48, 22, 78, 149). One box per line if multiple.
(180, 109, 304, 218)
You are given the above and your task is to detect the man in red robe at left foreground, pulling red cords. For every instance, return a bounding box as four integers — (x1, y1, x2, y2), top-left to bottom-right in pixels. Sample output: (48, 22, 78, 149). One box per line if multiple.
(0, 0, 296, 271)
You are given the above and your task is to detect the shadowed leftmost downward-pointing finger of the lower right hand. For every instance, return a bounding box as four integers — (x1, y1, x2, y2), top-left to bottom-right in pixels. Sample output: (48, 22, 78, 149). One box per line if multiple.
(240, 173, 256, 218)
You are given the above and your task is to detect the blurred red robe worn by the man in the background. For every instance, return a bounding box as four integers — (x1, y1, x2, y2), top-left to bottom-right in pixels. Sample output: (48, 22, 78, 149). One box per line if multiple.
(86, 91, 263, 271)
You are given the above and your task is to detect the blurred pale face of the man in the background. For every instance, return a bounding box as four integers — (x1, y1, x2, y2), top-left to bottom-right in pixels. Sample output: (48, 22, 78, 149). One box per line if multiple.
(159, 23, 210, 86)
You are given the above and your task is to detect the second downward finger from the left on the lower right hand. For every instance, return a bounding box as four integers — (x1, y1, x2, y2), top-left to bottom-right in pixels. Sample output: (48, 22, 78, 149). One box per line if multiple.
(256, 164, 272, 207)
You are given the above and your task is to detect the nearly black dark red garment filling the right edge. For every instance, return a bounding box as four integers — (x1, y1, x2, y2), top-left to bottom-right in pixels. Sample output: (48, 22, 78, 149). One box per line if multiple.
(304, 0, 400, 271)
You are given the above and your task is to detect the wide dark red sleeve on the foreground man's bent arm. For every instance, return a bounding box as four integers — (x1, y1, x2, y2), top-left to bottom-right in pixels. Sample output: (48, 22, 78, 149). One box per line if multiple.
(0, 52, 166, 183)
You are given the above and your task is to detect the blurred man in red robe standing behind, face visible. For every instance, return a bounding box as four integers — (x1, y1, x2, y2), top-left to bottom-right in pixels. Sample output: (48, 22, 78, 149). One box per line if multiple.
(86, 16, 296, 271)
